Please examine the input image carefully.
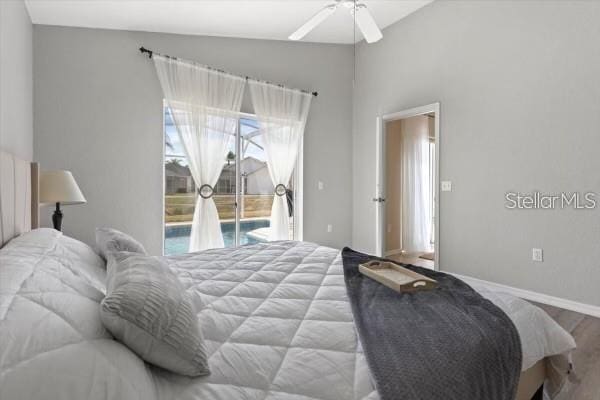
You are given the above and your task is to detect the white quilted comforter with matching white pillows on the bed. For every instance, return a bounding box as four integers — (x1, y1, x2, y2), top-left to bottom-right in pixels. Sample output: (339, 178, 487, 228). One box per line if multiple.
(0, 229, 574, 400)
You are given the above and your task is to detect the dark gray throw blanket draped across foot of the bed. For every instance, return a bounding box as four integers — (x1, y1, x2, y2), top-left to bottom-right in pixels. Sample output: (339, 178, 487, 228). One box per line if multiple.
(342, 248, 522, 400)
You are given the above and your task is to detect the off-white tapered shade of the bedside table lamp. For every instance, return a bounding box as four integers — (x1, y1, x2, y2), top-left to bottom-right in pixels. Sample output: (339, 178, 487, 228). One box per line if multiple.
(40, 171, 86, 205)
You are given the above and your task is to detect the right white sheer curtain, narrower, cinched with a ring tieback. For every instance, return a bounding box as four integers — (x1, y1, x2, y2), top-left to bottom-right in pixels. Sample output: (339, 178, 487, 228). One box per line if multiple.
(248, 80, 312, 240)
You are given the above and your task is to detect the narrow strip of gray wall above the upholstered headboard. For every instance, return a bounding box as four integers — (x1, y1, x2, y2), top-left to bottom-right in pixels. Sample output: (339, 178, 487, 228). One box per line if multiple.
(0, 0, 33, 160)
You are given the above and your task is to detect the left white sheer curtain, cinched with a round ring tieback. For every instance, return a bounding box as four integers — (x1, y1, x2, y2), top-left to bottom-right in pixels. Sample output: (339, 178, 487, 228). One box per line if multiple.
(153, 54, 245, 251)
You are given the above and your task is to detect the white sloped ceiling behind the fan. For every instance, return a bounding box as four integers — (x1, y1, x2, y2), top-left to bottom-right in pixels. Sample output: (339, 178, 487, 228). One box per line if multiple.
(25, 0, 433, 44)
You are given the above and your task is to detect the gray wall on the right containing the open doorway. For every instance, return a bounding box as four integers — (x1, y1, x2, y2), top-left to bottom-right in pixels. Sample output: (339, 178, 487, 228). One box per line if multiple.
(353, 1, 600, 305)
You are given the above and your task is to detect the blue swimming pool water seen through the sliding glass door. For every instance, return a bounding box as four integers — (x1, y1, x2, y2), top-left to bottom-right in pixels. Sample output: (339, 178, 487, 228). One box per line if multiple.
(165, 219, 269, 255)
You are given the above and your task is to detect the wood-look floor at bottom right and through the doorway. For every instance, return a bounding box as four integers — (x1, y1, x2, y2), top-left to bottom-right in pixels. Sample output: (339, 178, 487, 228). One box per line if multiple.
(387, 255, 600, 400)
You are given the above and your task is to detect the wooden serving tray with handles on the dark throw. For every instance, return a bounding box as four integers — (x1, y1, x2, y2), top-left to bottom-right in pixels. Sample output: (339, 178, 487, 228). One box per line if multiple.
(358, 261, 437, 293)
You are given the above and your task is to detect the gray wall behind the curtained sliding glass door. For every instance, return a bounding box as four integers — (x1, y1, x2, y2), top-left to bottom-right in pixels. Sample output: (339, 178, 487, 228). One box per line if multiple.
(34, 26, 353, 254)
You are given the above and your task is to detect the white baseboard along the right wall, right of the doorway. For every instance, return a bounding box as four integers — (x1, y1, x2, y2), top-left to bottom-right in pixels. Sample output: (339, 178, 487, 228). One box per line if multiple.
(450, 273, 600, 318)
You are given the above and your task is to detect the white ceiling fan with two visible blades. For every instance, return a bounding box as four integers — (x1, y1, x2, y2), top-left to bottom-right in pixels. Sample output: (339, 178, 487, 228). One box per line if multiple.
(289, 0, 383, 43)
